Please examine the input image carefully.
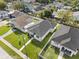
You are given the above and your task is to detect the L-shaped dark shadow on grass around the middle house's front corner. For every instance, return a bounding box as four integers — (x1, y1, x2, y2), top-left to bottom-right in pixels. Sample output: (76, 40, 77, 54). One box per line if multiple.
(32, 33, 52, 48)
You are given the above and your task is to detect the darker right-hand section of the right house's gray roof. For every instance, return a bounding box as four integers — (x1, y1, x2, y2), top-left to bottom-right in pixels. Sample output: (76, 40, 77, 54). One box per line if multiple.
(64, 28, 79, 50)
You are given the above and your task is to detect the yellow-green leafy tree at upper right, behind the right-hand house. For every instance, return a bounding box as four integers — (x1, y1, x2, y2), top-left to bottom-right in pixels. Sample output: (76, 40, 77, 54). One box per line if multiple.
(58, 10, 74, 22)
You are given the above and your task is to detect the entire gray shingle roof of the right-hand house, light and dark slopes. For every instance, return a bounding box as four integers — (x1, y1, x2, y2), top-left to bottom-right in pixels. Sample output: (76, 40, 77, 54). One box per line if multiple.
(53, 25, 79, 51)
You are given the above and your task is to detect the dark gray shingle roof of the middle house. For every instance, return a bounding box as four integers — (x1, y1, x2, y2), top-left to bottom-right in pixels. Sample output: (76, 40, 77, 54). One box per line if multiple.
(28, 20, 55, 40)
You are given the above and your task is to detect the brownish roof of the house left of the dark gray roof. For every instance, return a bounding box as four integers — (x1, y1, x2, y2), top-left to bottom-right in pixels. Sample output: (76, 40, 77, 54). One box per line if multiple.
(13, 14, 33, 28)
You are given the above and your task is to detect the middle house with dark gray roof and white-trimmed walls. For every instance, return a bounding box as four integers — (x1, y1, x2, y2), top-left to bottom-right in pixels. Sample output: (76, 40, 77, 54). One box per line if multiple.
(28, 20, 56, 42)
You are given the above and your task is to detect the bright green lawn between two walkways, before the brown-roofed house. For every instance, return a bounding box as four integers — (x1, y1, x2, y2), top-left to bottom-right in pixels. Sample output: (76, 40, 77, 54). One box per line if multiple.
(4, 31, 30, 49)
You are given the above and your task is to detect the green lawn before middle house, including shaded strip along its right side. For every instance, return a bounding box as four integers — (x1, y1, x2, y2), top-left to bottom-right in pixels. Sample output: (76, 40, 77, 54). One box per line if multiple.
(22, 33, 52, 59)
